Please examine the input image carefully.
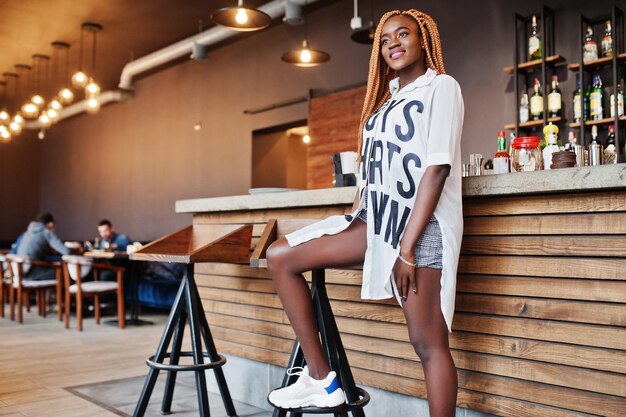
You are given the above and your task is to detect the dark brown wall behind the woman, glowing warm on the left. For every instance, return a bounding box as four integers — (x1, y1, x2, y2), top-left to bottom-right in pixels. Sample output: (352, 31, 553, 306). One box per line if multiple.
(0, 0, 612, 240)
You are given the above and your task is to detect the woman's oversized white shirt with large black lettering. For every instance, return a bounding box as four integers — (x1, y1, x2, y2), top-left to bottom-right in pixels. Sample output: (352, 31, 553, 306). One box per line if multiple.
(286, 68, 464, 331)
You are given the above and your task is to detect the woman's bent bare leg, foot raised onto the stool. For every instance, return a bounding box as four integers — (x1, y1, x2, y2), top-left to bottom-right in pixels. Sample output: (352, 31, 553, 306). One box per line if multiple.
(267, 219, 367, 379)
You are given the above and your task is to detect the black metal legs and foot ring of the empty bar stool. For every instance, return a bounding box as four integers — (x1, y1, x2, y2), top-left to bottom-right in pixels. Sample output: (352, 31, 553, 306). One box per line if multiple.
(133, 264, 237, 417)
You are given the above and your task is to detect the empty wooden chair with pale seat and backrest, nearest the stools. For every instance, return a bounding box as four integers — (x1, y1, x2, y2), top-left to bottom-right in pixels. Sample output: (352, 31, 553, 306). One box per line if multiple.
(63, 255, 126, 332)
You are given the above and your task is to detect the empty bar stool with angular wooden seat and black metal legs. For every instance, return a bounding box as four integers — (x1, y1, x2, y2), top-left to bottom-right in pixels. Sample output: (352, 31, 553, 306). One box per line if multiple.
(131, 225, 252, 417)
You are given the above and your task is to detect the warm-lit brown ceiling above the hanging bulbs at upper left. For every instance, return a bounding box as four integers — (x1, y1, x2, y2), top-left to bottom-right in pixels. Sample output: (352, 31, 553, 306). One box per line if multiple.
(0, 0, 268, 101)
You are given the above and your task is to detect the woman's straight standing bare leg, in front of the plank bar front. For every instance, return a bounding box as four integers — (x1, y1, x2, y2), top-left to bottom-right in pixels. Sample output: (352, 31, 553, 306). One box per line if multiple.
(404, 268, 458, 417)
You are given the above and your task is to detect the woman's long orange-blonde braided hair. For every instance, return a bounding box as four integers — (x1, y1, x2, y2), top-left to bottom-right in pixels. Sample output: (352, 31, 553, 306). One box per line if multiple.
(358, 9, 446, 159)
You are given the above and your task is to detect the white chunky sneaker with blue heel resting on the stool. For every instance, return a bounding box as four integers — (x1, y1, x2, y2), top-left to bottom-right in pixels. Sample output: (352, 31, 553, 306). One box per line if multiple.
(267, 366, 346, 408)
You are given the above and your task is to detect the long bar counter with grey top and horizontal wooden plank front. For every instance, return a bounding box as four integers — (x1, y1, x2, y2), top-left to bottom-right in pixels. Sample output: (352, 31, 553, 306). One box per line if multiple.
(176, 164, 626, 417)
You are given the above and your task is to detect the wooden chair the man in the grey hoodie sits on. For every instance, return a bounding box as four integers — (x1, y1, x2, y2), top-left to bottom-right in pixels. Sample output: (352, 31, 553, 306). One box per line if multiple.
(6, 254, 62, 323)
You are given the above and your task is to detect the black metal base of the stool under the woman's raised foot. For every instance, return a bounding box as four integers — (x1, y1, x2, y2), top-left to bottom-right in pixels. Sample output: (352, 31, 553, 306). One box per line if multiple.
(270, 269, 370, 417)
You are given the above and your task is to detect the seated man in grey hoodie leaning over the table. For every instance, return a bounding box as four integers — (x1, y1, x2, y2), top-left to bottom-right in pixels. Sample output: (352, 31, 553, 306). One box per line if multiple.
(17, 213, 81, 280)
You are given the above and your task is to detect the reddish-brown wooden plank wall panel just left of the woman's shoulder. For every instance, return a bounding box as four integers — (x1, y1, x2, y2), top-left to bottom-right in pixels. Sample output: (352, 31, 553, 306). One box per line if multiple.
(307, 87, 365, 189)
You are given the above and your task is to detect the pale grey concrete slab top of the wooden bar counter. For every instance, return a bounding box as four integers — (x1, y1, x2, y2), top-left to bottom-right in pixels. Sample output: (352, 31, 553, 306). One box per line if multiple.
(176, 164, 626, 213)
